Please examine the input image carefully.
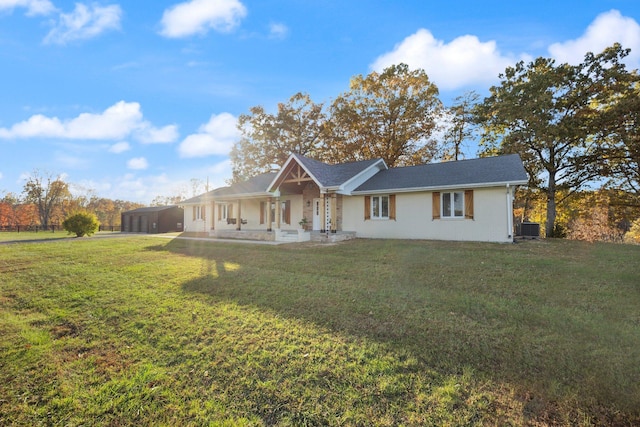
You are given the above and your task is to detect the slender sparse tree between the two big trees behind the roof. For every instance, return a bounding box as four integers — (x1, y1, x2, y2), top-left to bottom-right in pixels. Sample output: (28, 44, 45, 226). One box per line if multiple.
(440, 91, 480, 161)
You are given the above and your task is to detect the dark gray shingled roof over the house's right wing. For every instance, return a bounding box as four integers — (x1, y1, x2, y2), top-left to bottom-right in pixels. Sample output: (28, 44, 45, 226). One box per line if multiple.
(354, 154, 528, 193)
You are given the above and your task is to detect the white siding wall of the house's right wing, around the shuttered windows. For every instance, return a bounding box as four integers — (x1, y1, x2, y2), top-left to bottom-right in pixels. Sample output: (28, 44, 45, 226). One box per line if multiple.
(342, 187, 513, 242)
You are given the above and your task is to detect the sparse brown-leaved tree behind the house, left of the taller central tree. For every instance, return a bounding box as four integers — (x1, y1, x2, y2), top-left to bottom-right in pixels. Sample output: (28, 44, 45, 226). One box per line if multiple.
(230, 93, 326, 182)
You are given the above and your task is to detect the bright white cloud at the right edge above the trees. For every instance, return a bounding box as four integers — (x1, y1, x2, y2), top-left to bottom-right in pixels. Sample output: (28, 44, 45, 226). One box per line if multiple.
(549, 10, 640, 68)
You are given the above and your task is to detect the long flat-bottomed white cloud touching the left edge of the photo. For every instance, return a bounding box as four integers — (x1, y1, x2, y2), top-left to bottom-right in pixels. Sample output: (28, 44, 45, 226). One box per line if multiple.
(0, 101, 178, 143)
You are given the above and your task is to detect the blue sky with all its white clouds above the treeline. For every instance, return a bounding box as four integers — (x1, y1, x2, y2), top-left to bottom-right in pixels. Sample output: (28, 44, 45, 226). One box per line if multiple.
(0, 0, 640, 203)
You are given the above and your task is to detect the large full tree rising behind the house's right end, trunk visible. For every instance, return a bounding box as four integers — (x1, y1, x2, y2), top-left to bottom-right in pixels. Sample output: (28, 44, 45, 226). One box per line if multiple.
(475, 45, 628, 236)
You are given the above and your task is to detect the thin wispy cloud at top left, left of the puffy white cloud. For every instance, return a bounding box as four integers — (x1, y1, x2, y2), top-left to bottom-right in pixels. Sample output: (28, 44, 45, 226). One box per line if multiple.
(43, 0, 122, 44)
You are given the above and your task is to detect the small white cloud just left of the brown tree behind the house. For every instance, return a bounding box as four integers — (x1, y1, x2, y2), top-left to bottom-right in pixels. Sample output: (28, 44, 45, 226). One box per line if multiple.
(178, 113, 240, 157)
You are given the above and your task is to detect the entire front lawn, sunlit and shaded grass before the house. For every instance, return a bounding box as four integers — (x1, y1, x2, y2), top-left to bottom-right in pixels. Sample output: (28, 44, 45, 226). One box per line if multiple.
(0, 236, 640, 426)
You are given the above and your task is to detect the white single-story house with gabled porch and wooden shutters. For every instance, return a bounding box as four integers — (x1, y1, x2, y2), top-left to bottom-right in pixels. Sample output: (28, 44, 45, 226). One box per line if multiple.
(182, 154, 528, 242)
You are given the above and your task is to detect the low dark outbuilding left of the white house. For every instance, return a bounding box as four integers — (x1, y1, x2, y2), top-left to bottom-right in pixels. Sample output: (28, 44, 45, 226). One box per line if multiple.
(120, 205, 184, 234)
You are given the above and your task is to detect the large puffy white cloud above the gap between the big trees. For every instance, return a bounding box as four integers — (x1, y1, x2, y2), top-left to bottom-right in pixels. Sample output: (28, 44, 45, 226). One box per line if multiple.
(371, 29, 519, 89)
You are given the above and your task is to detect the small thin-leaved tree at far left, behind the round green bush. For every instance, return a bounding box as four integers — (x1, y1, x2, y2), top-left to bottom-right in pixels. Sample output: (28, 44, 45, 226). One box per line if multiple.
(23, 170, 71, 228)
